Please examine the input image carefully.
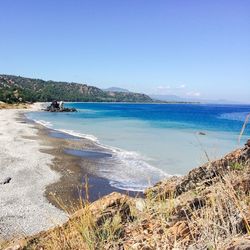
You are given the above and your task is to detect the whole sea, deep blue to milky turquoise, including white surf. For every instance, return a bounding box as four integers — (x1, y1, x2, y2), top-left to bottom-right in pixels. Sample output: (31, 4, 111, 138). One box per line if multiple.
(27, 103, 250, 190)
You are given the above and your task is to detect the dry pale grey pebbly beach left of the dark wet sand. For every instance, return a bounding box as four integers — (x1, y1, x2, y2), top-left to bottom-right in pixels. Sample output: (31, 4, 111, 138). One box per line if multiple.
(0, 105, 67, 239)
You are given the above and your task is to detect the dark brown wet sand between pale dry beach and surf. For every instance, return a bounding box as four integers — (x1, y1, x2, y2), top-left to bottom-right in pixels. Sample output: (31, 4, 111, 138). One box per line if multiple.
(23, 114, 142, 212)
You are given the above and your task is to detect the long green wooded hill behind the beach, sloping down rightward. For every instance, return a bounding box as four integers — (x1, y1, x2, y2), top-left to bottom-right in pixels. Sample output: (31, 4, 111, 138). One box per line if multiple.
(0, 75, 153, 103)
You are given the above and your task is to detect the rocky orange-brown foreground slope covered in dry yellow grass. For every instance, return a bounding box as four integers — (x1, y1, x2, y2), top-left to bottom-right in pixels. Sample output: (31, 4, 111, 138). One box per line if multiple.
(3, 140, 250, 250)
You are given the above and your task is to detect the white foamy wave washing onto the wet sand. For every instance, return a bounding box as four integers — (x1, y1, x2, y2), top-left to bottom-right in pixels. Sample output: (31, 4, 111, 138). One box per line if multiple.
(30, 119, 172, 192)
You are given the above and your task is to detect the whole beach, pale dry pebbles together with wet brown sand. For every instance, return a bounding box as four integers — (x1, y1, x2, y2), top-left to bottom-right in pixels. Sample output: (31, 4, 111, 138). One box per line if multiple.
(0, 103, 141, 240)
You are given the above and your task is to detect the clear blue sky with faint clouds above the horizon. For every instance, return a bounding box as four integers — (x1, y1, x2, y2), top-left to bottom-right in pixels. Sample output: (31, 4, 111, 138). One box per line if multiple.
(0, 0, 250, 103)
